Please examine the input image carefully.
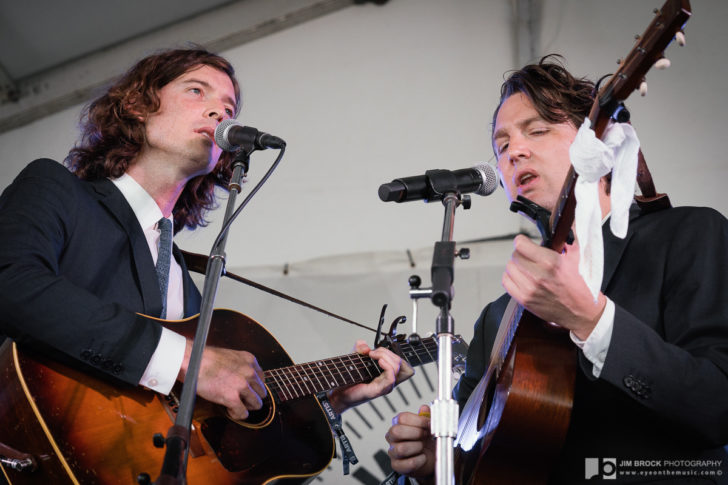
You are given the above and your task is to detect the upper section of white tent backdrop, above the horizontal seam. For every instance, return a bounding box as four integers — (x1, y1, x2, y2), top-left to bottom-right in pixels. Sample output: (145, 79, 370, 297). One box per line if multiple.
(0, 0, 728, 267)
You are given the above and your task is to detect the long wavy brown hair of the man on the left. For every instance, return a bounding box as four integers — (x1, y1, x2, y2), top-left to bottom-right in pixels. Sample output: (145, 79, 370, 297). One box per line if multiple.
(64, 47, 240, 232)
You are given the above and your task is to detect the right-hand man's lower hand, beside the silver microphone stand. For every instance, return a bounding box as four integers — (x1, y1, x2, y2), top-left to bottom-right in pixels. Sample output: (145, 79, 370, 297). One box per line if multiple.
(384, 404, 435, 485)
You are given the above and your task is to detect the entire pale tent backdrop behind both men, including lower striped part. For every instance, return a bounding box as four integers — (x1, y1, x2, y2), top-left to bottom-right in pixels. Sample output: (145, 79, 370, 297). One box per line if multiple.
(0, 0, 728, 483)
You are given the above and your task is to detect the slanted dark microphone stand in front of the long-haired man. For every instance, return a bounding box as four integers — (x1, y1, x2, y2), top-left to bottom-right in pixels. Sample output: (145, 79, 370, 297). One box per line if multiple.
(154, 143, 255, 485)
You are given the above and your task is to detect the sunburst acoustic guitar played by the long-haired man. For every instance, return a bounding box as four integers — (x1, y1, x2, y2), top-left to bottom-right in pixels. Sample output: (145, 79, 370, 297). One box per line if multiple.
(0, 310, 464, 485)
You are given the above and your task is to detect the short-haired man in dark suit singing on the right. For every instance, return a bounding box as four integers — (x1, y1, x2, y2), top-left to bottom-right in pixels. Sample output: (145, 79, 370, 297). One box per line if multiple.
(386, 57, 728, 485)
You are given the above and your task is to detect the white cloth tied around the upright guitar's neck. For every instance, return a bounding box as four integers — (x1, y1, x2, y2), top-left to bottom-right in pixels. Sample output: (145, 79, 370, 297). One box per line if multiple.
(569, 118, 640, 301)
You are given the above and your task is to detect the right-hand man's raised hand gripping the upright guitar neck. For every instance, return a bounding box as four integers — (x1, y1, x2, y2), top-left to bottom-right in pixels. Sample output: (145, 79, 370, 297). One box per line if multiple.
(501, 235, 607, 340)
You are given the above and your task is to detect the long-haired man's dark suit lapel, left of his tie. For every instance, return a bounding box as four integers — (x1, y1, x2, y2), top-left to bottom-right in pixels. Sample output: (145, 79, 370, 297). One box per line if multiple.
(91, 179, 162, 316)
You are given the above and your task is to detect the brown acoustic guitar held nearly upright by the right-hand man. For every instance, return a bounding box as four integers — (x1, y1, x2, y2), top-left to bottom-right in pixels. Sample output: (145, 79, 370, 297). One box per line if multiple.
(455, 0, 690, 485)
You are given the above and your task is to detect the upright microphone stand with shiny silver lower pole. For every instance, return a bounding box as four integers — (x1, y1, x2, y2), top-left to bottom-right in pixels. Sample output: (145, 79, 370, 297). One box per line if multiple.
(430, 192, 470, 485)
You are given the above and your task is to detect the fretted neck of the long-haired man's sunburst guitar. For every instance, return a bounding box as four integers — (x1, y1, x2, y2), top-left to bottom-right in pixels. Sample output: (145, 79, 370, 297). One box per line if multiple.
(264, 337, 437, 402)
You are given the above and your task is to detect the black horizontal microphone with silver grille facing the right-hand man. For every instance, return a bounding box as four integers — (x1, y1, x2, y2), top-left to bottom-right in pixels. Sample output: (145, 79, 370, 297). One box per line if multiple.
(379, 162, 499, 202)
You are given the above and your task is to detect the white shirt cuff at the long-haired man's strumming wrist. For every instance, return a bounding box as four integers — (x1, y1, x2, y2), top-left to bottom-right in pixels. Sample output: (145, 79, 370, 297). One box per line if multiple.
(139, 328, 187, 394)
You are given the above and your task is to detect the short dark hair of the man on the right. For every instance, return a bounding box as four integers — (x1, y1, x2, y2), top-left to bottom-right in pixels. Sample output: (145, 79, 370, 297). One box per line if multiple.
(492, 54, 596, 140)
